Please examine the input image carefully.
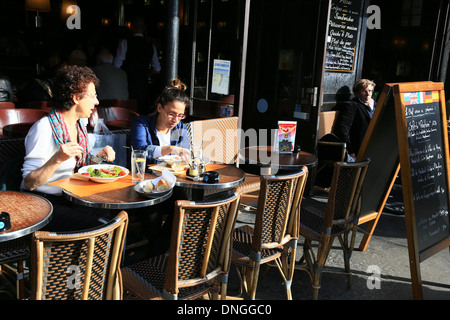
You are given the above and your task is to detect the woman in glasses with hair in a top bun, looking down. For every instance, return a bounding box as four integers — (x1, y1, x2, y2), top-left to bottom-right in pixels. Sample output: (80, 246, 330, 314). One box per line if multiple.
(130, 79, 190, 163)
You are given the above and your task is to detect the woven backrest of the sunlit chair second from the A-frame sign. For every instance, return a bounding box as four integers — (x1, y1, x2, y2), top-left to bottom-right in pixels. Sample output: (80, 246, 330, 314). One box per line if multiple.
(252, 167, 308, 253)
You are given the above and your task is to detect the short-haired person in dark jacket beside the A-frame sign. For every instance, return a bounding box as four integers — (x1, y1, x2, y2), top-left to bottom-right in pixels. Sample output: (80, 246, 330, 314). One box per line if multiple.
(333, 79, 376, 161)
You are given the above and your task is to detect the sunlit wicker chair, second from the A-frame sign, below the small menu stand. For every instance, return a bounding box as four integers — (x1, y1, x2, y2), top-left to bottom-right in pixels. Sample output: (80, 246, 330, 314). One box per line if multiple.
(231, 167, 308, 299)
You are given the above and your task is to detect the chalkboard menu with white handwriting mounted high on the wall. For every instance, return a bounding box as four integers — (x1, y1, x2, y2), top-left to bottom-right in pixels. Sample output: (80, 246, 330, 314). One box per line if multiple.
(325, 0, 362, 72)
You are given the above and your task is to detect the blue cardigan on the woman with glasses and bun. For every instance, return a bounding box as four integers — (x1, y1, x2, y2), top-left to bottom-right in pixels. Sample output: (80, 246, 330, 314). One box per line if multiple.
(130, 114, 189, 163)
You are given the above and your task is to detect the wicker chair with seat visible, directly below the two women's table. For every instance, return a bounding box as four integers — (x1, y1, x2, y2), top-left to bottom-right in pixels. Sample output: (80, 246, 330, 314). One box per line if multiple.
(122, 190, 240, 300)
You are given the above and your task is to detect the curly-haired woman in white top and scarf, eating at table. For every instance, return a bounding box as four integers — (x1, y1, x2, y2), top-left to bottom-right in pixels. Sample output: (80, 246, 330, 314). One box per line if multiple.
(21, 66, 115, 231)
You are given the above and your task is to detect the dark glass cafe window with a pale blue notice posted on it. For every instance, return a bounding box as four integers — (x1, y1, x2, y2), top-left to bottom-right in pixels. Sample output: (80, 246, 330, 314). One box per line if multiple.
(181, 0, 245, 118)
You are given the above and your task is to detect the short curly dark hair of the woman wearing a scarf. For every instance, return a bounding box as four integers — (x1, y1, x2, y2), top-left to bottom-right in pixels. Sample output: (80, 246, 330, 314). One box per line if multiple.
(52, 66, 99, 110)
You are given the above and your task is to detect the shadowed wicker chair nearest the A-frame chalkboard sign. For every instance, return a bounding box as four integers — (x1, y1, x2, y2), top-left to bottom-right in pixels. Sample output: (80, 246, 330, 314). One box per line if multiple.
(297, 159, 370, 299)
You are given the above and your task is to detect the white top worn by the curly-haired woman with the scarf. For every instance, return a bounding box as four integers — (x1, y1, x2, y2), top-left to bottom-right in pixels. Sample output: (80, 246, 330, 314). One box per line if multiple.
(21, 117, 76, 195)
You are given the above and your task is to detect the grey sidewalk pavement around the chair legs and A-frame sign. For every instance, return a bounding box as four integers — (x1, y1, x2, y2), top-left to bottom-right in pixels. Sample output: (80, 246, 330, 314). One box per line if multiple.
(229, 200, 450, 300)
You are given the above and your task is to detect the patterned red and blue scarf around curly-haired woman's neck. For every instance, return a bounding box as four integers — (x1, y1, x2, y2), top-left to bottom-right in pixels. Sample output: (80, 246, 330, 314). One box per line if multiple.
(48, 108, 91, 169)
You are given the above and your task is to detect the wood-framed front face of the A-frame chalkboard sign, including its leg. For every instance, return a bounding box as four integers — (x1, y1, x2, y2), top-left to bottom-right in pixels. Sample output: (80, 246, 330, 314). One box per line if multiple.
(394, 82, 450, 299)
